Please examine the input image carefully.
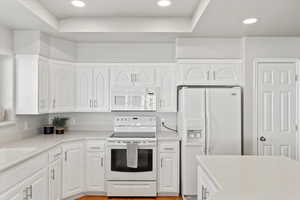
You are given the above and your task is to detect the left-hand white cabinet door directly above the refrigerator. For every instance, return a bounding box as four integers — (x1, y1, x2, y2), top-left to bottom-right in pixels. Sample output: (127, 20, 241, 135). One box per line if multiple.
(180, 63, 211, 85)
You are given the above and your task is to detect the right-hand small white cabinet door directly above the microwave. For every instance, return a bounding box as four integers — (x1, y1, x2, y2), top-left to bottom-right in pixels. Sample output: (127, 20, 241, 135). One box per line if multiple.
(133, 65, 155, 86)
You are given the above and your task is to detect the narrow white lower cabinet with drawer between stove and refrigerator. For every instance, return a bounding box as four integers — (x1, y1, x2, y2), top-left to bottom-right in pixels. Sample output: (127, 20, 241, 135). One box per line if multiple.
(158, 141, 179, 196)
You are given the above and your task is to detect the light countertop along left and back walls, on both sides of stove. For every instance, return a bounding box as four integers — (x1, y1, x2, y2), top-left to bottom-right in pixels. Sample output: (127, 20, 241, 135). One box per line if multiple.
(0, 131, 180, 172)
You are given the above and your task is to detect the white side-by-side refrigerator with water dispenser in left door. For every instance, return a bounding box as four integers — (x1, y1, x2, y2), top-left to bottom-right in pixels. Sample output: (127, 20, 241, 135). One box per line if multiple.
(178, 87, 242, 197)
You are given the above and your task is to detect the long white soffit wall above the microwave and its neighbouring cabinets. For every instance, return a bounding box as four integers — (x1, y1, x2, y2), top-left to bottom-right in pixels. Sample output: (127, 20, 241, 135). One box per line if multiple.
(77, 42, 175, 62)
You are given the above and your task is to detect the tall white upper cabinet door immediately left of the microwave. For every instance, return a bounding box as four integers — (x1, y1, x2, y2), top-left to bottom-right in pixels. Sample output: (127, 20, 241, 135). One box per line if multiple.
(93, 67, 110, 112)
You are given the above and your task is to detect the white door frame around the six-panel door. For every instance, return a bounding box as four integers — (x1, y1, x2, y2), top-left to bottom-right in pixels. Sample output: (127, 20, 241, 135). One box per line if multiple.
(252, 58, 300, 160)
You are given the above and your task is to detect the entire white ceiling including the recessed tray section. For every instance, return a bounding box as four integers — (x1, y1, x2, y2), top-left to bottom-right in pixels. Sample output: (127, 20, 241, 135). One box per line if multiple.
(0, 0, 300, 42)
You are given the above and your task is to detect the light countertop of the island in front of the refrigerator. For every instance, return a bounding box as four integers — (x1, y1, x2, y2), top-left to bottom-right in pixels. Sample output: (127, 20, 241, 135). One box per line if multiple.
(197, 156, 300, 200)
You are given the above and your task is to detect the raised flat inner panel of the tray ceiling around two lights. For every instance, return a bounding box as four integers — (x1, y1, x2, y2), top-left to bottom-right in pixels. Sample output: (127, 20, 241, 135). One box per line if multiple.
(39, 0, 200, 19)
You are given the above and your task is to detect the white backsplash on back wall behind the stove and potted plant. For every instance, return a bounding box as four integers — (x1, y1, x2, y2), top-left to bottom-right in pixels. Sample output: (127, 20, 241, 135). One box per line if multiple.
(49, 112, 177, 131)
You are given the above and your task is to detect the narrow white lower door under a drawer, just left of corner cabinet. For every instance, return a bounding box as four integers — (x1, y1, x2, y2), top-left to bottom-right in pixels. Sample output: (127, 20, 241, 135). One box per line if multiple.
(49, 158, 62, 200)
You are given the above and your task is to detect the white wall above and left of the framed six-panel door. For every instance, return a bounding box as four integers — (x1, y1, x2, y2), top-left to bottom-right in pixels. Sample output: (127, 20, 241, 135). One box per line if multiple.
(244, 37, 300, 154)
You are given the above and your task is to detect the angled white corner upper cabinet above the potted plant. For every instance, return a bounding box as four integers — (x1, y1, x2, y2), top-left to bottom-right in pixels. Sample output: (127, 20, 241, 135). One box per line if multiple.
(50, 61, 75, 112)
